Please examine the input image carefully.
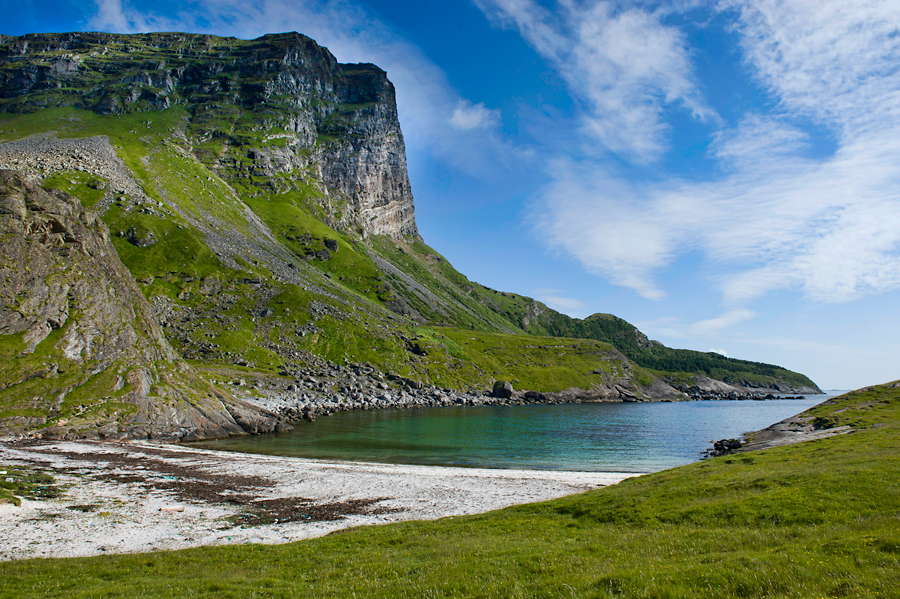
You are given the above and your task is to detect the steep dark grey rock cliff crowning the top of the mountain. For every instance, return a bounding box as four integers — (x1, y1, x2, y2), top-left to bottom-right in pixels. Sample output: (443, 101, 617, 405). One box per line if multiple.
(0, 33, 418, 238)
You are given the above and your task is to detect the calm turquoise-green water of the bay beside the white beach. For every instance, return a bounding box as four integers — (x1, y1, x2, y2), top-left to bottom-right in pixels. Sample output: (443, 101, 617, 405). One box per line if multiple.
(198, 395, 828, 472)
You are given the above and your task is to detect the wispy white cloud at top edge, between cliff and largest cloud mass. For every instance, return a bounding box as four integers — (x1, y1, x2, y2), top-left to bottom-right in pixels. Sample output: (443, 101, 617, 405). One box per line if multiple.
(476, 0, 718, 162)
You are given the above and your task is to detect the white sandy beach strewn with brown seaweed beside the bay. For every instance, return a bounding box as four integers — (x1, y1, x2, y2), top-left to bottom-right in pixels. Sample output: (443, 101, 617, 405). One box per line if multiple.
(0, 441, 631, 560)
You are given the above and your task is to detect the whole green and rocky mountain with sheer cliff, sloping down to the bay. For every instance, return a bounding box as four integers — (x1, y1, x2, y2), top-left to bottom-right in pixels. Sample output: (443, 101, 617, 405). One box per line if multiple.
(0, 33, 818, 438)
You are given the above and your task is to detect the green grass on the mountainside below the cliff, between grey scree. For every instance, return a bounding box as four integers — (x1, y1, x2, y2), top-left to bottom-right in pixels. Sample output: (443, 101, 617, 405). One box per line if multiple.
(0, 108, 649, 398)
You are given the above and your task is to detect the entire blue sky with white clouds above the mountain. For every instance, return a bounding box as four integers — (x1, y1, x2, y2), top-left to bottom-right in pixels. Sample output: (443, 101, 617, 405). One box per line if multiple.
(0, 0, 900, 389)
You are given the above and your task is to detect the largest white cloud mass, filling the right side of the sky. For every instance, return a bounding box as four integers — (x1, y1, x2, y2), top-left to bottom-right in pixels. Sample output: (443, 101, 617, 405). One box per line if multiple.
(534, 1, 900, 305)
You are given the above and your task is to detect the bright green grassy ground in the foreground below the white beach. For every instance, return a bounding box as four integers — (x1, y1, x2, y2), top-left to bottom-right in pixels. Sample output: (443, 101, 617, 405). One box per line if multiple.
(0, 385, 900, 599)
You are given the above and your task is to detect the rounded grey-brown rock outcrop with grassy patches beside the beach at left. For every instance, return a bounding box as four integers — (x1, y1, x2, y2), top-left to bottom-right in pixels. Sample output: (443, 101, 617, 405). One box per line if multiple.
(0, 171, 279, 438)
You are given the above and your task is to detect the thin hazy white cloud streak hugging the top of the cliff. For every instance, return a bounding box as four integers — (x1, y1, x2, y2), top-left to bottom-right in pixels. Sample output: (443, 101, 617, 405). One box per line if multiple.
(89, 0, 530, 178)
